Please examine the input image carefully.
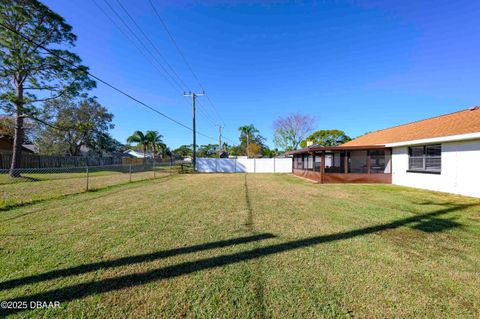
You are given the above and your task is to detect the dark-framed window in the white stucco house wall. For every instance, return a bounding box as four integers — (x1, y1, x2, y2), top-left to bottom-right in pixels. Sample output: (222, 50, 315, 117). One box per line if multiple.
(408, 144, 442, 173)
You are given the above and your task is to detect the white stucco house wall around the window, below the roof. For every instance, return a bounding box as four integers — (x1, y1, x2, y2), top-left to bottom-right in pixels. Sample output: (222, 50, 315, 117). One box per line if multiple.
(392, 140, 480, 197)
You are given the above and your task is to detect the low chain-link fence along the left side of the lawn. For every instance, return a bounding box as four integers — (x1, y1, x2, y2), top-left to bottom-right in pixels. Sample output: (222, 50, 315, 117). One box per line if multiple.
(0, 161, 183, 211)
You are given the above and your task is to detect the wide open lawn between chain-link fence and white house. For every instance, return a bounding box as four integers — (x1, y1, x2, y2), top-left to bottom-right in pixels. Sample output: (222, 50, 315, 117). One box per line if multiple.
(0, 174, 480, 318)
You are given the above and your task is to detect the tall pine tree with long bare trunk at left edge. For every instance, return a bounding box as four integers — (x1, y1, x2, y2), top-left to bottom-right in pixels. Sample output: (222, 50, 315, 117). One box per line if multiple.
(0, 0, 95, 177)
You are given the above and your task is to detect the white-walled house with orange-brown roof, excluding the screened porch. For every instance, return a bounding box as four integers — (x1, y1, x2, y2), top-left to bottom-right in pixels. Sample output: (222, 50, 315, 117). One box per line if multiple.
(342, 107, 480, 197)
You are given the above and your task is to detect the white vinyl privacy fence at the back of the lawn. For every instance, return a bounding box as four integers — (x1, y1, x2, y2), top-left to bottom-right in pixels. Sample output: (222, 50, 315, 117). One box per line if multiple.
(197, 158, 292, 173)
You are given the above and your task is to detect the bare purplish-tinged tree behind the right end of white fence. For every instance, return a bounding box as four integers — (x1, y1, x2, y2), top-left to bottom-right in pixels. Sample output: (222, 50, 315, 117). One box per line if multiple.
(273, 113, 316, 151)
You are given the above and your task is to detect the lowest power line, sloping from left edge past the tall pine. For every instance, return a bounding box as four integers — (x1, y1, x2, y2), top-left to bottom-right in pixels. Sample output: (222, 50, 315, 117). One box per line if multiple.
(0, 22, 216, 141)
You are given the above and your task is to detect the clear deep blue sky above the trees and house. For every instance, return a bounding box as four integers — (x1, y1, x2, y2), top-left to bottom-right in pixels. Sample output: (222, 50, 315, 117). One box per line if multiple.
(40, 0, 480, 148)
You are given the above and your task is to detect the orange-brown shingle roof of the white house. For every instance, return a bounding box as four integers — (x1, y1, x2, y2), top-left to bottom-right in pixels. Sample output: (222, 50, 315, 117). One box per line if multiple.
(342, 106, 480, 146)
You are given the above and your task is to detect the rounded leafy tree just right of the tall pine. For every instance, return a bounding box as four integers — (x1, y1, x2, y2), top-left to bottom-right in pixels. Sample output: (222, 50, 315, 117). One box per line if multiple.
(36, 95, 114, 156)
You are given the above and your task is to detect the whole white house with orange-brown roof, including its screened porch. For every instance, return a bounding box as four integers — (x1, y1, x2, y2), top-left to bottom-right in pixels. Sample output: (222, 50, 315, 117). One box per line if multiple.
(290, 107, 480, 197)
